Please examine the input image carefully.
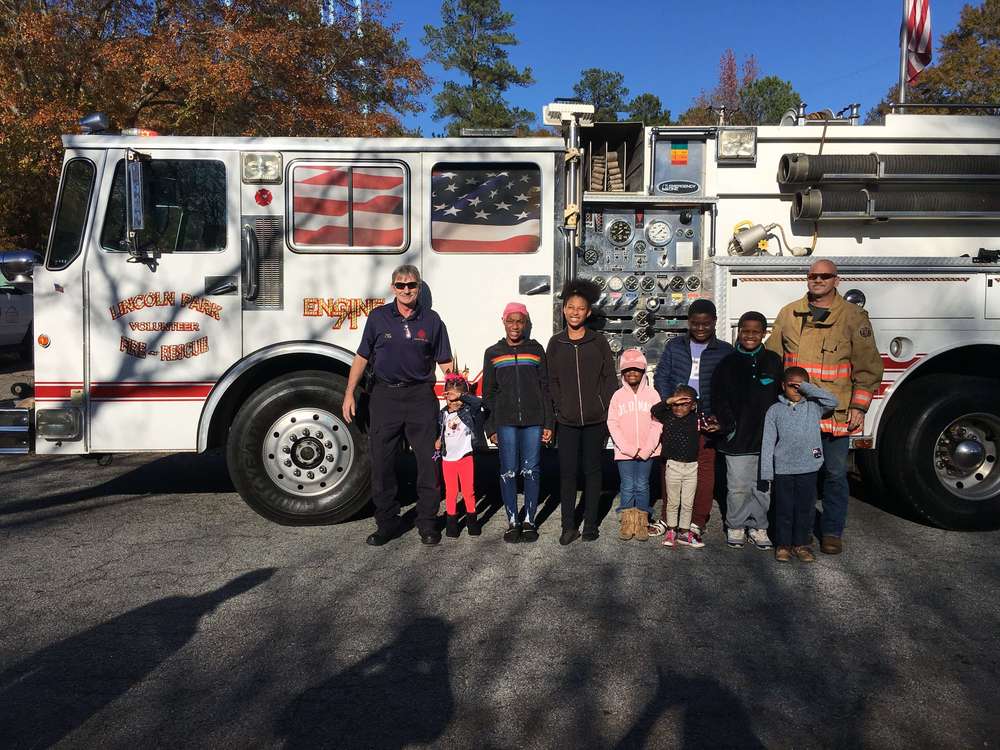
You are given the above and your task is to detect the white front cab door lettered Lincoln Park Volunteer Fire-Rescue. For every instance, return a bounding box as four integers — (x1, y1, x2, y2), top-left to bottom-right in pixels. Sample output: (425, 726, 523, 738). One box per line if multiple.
(86, 148, 242, 451)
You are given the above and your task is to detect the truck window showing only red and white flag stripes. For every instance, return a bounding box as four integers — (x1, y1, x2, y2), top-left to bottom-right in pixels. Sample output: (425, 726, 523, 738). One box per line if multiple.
(292, 164, 406, 247)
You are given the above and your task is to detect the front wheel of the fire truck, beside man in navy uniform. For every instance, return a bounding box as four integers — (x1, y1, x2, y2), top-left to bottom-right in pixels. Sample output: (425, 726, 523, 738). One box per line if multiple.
(226, 371, 370, 526)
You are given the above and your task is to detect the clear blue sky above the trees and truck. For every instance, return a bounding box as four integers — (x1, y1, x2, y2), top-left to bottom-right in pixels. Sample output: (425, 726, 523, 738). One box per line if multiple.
(388, 0, 979, 136)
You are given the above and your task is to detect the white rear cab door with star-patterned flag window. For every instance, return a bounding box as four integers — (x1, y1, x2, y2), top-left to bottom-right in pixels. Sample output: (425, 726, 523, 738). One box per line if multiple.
(423, 153, 561, 385)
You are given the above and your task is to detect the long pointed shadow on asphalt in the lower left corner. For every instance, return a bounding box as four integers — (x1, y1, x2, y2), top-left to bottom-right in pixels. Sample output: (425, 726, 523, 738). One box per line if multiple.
(0, 568, 276, 748)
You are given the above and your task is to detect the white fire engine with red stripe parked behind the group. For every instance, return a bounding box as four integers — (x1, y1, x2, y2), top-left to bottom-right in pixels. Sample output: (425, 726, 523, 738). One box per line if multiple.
(3, 101, 1000, 527)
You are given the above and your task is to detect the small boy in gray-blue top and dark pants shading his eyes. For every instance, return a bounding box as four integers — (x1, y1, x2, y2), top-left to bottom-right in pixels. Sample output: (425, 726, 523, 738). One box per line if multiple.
(757, 367, 837, 562)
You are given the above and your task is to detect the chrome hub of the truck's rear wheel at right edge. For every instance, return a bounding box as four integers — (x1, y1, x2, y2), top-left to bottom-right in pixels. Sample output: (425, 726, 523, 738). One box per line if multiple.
(934, 414, 1000, 500)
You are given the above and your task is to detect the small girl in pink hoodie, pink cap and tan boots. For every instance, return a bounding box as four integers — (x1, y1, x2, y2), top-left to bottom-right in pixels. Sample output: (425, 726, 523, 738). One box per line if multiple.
(608, 349, 663, 541)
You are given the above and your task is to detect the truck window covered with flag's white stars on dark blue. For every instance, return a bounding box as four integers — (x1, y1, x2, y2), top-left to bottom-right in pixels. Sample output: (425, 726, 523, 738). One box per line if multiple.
(431, 165, 542, 253)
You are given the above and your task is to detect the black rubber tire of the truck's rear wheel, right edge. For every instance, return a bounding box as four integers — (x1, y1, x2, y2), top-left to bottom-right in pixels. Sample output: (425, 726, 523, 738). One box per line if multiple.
(878, 375, 1000, 529)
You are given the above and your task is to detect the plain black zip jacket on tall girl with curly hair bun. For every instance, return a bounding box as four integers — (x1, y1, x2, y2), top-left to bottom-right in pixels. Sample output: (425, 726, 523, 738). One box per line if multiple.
(545, 328, 618, 427)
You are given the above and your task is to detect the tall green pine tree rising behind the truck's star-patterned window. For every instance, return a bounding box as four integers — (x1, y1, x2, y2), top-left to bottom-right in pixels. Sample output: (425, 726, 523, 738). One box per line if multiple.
(423, 0, 535, 136)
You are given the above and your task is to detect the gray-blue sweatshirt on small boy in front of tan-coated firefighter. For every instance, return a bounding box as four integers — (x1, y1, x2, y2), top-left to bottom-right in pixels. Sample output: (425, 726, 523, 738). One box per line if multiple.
(760, 383, 837, 480)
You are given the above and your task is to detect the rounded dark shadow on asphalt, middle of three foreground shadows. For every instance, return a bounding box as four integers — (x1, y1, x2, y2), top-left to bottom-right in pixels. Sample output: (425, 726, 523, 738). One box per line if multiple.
(276, 617, 455, 748)
